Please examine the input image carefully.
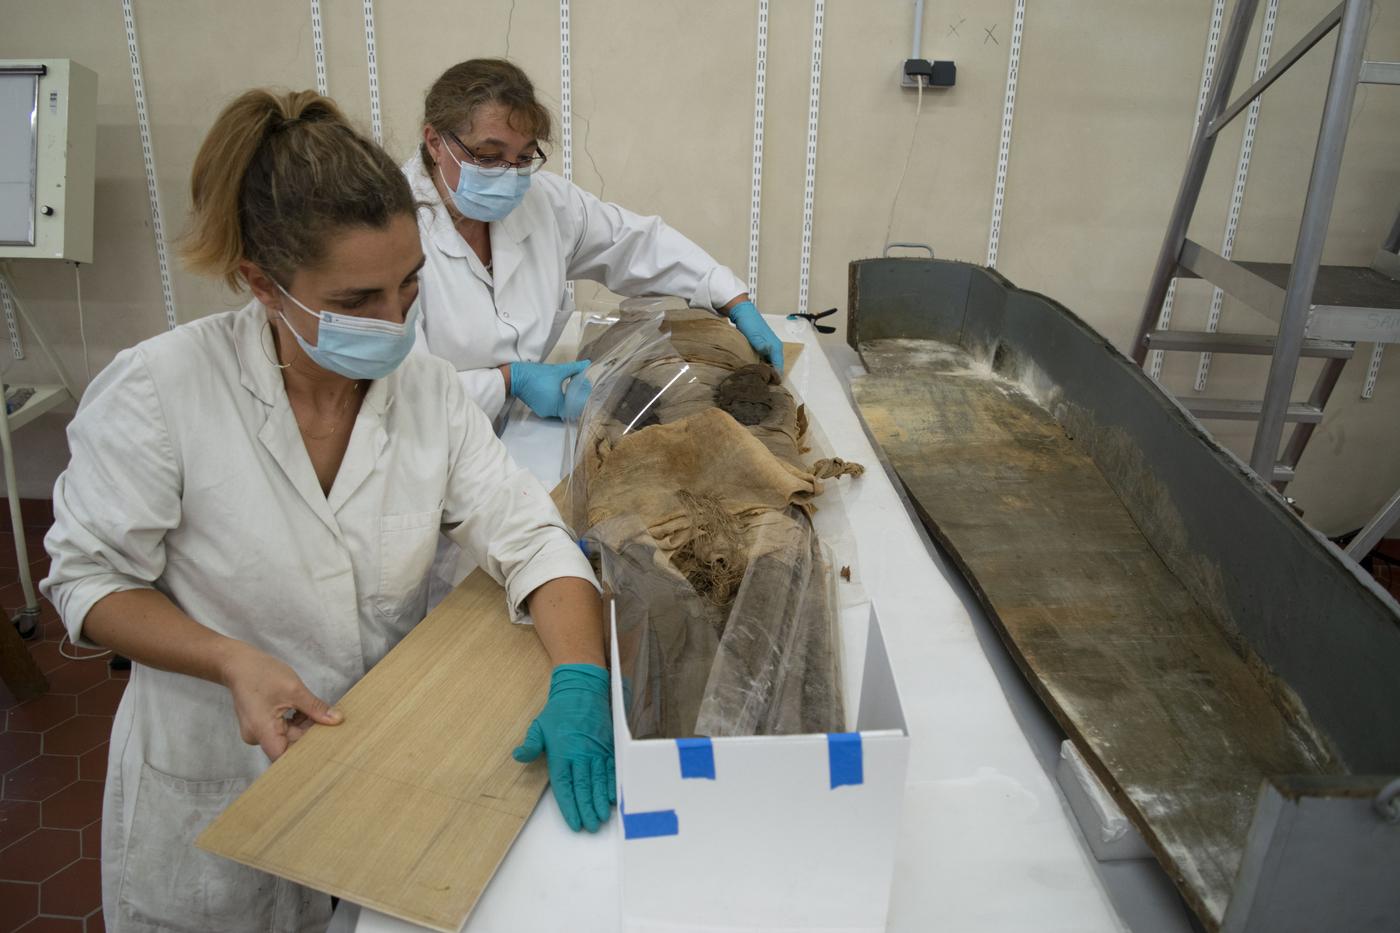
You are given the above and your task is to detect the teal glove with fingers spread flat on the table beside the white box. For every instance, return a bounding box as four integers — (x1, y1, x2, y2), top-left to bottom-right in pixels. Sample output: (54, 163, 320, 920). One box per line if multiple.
(512, 664, 617, 832)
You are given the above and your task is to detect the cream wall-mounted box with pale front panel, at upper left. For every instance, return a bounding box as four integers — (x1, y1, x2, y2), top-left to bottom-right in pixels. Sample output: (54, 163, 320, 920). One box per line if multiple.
(0, 59, 97, 262)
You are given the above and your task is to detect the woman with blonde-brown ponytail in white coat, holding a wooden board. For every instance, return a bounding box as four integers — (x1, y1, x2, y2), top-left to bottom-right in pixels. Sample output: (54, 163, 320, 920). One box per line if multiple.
(42, 91, 613, 933)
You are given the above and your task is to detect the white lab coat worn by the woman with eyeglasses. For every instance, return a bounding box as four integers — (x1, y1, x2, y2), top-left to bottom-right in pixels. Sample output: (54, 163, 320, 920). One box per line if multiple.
(403, 154, 748, 419)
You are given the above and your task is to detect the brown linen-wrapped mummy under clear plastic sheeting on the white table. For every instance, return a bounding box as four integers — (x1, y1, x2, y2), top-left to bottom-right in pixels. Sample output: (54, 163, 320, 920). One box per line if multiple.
(566, 305, 860, 738)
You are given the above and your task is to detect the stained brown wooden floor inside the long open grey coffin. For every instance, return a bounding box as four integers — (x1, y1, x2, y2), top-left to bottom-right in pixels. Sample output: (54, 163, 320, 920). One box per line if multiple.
(853, 340, 1336, 929)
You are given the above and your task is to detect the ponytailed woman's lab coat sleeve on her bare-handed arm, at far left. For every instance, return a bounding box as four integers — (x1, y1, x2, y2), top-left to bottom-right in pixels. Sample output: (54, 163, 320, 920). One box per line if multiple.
(39, 347, 183, 646)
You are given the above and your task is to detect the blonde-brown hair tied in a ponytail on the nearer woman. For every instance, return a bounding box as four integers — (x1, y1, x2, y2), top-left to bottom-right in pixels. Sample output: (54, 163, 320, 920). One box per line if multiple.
(181, 88, 414, 290)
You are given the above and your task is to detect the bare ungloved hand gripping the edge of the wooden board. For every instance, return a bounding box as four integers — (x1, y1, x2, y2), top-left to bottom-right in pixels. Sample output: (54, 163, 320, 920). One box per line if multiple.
(221, 642, 344, 761)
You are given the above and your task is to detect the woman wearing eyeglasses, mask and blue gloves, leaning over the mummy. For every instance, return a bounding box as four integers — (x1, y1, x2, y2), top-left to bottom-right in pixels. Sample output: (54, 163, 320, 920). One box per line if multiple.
(403, 59, 783, 419)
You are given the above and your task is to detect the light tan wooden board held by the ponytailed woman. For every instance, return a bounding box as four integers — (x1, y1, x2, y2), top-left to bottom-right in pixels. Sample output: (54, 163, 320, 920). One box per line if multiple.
(197, 570, 550, 933)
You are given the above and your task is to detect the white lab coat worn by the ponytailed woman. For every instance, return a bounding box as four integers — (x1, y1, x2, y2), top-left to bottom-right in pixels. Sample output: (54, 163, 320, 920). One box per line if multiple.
(42, 301, 592, 933)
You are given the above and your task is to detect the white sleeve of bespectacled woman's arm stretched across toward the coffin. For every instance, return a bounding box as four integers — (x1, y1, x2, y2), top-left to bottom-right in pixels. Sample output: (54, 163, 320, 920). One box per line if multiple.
(554, 179, 749, 311)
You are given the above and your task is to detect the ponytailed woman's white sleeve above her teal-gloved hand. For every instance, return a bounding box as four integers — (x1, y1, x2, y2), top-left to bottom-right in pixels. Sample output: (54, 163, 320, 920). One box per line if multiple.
(442, 369, 598, 622)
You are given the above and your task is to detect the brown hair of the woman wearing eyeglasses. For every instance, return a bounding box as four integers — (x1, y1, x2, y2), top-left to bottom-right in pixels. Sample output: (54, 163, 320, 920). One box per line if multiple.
(419, 59, 554, 168)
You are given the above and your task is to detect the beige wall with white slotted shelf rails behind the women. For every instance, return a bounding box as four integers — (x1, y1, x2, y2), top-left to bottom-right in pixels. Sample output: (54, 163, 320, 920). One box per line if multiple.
(0, 0, 1400, 532)
